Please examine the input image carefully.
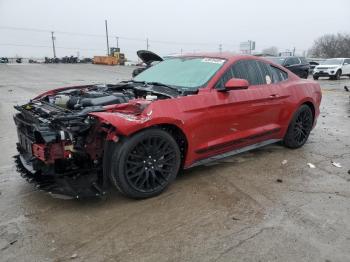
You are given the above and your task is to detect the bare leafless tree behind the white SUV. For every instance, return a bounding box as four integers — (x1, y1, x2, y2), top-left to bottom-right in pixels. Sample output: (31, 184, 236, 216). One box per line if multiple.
(308, 34, 350, 58)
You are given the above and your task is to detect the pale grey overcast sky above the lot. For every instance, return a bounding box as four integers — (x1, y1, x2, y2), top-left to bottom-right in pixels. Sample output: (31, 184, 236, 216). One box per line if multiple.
(0, 0, 350, 59)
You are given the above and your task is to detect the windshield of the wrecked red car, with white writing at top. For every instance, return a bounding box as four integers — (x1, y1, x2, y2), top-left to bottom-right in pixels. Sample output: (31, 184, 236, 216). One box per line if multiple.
(134, 57, 226, 90)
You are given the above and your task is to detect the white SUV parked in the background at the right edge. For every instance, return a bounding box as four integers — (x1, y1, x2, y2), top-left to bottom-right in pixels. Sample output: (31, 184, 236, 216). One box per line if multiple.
(313, 58, 350, 80)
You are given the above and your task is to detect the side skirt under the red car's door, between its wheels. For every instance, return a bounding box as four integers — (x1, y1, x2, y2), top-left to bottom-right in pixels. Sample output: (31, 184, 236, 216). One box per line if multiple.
(185, 139, 281, 169)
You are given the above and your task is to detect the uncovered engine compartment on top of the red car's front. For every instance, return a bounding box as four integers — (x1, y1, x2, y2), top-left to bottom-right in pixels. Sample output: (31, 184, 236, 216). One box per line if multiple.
(16, 82, 179, 117)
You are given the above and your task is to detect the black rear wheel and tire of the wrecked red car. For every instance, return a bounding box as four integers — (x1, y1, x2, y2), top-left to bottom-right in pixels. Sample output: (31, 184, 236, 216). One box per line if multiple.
(283, 105, 313, 148)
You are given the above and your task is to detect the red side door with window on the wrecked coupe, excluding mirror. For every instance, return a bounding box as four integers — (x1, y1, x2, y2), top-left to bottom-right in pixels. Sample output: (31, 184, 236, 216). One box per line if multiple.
(191, 60, 288, 158)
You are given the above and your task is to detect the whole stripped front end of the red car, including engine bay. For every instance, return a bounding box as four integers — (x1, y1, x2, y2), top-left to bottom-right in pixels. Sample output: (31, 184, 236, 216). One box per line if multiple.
(14, 81, 184, 197)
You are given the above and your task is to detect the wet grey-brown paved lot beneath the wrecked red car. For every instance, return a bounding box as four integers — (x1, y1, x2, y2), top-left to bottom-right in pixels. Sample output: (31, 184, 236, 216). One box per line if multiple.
(0, 64, 350, 262)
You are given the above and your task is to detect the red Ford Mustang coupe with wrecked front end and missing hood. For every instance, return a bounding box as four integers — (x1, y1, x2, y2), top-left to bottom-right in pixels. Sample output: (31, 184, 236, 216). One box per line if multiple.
(14, 54, 322, 198)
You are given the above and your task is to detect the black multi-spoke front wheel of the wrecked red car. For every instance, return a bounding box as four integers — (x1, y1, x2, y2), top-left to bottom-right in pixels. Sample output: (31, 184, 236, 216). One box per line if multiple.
(105, 128, 181, 199)
